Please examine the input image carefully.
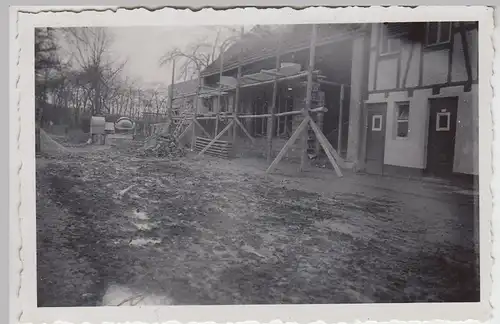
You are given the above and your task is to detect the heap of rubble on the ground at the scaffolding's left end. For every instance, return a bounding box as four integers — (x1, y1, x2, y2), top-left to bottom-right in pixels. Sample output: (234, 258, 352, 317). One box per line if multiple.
(141, 133, 186, 158)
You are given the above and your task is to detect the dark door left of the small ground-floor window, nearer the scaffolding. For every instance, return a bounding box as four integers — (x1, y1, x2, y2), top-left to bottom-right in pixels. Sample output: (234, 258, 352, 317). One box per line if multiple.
(366, 103, 387, 174)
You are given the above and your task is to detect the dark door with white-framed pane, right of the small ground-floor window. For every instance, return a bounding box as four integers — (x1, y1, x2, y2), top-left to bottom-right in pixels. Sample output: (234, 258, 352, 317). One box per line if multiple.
(426, 97, 458, 177)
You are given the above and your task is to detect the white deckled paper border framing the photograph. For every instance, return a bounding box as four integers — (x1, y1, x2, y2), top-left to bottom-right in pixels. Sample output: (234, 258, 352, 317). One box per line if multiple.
(9, 6, 500, 324)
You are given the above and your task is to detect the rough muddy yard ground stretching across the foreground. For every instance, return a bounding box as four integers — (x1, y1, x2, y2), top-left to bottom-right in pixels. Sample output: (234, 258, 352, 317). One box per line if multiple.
(36, 136, 479, 306)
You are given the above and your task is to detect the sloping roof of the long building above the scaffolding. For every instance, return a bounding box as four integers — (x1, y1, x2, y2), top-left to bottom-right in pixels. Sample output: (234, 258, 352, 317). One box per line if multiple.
(201, 24, 363, 77)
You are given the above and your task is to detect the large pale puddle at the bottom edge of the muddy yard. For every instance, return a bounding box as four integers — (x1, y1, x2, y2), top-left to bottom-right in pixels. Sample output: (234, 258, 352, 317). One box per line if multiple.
(101, 285, 174, 306)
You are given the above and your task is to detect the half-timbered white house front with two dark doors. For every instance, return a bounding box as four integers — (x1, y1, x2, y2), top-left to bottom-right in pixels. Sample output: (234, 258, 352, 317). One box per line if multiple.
(349, 22, 479, 177)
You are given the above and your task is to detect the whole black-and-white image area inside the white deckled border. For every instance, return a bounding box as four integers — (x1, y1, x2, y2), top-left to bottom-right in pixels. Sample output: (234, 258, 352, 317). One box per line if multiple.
(9, 5, 491, 324)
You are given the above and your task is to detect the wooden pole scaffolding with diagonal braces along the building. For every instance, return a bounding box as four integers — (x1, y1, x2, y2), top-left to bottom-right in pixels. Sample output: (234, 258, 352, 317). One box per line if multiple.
(168, 25, 345, 177)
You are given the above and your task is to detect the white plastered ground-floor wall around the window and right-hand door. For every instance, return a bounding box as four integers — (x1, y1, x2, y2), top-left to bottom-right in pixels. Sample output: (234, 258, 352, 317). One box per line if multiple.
(367, 85, 479, 175)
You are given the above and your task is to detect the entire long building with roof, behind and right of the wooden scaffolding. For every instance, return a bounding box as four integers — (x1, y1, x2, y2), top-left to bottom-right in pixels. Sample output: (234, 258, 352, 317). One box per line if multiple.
(181, 22, 479, 177)
